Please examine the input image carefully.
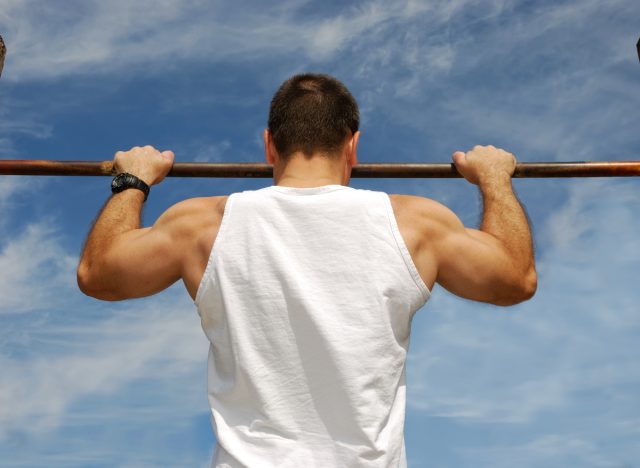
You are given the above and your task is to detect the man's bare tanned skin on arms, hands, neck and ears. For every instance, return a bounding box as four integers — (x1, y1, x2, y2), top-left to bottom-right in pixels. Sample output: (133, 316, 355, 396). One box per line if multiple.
(77, 134, 537, 306)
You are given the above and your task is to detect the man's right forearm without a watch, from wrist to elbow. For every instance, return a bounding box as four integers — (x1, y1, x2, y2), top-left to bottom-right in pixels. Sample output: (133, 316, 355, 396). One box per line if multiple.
(479, 177, 535, 274)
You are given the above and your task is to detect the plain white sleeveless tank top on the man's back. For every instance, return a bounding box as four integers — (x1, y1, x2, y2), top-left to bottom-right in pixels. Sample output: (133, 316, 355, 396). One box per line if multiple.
(194, 185, 431, 468)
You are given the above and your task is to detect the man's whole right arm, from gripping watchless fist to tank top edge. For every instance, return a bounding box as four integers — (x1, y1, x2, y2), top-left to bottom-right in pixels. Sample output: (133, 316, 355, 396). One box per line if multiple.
(394, 146, 537, 305)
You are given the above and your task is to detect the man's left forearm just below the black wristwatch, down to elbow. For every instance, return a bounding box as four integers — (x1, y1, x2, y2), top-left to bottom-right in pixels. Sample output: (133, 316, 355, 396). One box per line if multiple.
(79, 189, 144, 271)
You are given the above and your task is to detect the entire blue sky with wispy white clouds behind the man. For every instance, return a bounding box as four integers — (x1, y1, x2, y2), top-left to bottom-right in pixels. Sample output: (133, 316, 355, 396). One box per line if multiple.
(0, 0, 640, 468)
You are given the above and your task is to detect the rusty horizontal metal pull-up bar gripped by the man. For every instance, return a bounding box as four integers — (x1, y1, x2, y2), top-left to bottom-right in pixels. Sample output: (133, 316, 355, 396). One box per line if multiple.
(0, 159, 640, 178)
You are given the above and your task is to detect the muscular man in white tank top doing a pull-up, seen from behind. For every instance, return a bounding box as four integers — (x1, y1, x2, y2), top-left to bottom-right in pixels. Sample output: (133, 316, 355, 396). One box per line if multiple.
(78, 74, 536, 467)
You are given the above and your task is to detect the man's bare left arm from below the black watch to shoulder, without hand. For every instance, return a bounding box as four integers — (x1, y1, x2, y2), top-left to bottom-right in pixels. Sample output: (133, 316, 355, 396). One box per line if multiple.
(77, 190, 201, 301)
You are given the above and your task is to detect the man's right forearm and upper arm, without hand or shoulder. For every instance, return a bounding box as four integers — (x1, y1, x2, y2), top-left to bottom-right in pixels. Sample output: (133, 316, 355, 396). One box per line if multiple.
(435, 177, 537, 305)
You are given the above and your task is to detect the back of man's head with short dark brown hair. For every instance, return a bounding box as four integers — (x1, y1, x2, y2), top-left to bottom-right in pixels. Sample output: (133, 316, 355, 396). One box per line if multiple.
(268, 73, 360, 162)
